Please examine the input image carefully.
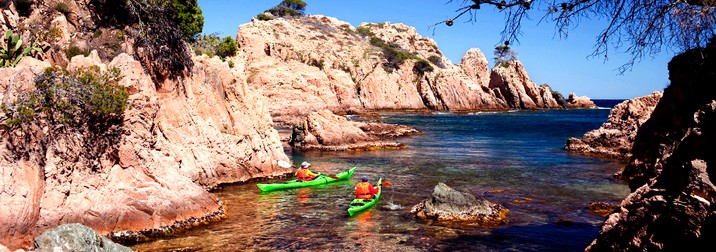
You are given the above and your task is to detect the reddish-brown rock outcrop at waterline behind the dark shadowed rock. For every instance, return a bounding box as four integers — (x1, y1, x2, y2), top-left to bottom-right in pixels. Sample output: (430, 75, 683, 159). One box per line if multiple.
(564, 92, 663, 160)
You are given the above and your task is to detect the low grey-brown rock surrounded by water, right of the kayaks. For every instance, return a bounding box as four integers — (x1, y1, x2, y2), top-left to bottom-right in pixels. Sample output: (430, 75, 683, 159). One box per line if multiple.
(410, 183, 509, 223)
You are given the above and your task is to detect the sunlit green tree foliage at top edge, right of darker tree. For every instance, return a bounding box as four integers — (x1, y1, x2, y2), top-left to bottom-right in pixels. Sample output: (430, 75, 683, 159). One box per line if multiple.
(171, 0, 204, 41)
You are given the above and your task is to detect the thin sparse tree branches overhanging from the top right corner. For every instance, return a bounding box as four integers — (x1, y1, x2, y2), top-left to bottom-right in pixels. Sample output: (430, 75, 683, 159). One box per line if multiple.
(444, 0, 716, 72)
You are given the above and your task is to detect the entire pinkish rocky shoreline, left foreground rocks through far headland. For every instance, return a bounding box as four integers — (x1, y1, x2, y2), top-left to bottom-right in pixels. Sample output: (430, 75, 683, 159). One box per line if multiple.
(0, 1, 608, 250)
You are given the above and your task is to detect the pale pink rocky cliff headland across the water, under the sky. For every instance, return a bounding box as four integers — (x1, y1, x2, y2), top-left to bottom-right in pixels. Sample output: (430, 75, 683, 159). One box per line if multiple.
(237, 16, 596, 122)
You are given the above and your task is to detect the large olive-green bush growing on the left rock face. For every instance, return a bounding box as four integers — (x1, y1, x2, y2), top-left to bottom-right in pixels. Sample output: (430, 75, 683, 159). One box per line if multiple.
(0, 66, 129, 171)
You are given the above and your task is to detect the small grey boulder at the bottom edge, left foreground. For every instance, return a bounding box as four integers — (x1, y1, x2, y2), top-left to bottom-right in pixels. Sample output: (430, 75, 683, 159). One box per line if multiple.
(35, 223, 133, 252)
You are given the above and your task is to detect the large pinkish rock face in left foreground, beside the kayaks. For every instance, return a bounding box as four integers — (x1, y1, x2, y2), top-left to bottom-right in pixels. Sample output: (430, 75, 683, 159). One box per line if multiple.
(0, 54, 288, 248)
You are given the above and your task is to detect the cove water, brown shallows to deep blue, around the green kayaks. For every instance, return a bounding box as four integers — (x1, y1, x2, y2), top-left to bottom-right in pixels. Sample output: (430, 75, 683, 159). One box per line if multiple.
(132, 109, 629, 251)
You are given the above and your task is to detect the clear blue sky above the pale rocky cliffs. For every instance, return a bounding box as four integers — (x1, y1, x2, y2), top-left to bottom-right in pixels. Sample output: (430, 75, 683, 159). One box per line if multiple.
(199, 0, 675, 99)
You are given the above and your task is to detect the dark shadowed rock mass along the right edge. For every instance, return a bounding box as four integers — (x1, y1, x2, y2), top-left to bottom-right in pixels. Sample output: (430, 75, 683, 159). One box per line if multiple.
(587, 40, 716, 251)
